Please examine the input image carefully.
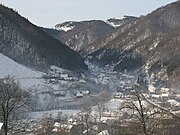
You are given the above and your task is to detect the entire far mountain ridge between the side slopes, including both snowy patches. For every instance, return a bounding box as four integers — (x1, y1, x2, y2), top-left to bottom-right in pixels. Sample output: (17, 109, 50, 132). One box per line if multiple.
(43, 16, 138, 56)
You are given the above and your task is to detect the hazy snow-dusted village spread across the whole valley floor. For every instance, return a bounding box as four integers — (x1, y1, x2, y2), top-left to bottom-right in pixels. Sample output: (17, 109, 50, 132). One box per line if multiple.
(1, 66, 180, 135)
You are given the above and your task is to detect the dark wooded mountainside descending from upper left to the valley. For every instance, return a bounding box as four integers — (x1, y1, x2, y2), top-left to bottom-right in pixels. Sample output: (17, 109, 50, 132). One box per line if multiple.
(0, 5, 87, 71)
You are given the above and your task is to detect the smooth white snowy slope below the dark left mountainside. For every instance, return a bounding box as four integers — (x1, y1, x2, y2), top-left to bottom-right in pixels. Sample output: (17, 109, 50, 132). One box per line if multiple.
(0, 53, 43, 88)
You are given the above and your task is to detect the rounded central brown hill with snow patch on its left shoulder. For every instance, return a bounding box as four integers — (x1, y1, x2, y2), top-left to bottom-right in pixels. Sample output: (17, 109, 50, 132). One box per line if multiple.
(55, 20, 114, 55)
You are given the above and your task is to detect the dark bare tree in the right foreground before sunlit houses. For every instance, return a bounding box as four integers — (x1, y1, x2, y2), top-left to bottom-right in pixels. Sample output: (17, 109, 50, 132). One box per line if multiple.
(120, 88, 165, 135)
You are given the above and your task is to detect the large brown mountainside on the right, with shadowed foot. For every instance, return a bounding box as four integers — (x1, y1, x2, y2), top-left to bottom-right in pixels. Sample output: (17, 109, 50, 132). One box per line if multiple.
(86, 1, 180, 86)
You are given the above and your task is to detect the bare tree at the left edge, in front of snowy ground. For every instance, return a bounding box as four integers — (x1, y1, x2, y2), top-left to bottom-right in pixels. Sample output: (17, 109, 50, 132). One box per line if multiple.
(0, 77, 29, 135)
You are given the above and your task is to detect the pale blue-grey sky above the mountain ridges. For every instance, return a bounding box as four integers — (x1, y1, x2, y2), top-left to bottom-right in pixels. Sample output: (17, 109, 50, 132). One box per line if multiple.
(0, 0, 175, 27)
